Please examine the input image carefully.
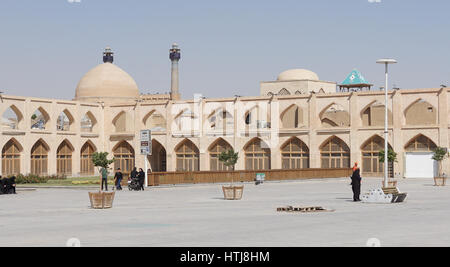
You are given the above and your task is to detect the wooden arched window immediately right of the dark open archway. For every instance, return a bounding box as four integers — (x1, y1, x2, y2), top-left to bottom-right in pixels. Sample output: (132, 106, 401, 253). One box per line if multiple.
(175, 140, 200, 172)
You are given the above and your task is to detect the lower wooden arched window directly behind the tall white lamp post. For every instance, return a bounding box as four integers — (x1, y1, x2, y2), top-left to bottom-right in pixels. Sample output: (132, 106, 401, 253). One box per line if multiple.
(361, 136, 393, 176)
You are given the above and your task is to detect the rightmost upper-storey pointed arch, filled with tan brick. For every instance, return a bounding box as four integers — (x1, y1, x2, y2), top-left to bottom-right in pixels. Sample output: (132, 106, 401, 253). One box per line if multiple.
(405, 98, 437, 125)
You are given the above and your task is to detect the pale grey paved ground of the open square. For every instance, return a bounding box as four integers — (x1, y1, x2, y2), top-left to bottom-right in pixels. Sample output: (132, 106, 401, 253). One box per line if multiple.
(0, 179, 450, 247)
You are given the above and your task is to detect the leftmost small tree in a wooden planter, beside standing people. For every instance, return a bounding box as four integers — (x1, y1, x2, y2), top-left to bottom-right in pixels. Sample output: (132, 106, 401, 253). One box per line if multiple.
(89, 152, 115, 209)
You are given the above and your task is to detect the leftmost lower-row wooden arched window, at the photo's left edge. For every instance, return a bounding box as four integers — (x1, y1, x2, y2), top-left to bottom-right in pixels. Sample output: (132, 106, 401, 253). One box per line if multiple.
(2, 139, 22, 176)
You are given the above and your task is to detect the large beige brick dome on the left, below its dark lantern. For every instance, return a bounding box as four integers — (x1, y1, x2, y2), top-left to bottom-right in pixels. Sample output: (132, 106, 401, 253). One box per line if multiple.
(75, 62, 139, 101)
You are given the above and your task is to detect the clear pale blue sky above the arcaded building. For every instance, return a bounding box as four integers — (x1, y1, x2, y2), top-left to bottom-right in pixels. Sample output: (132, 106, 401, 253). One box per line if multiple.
(0, 0, 450, 99)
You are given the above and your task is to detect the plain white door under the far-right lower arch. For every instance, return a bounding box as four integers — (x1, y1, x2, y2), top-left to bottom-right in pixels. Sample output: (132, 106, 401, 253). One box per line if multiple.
(405, 153, 437, 178)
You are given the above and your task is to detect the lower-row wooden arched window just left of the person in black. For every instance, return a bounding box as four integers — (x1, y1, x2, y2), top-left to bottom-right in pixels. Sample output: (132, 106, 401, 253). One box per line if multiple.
(320, 136, 350, 169)
